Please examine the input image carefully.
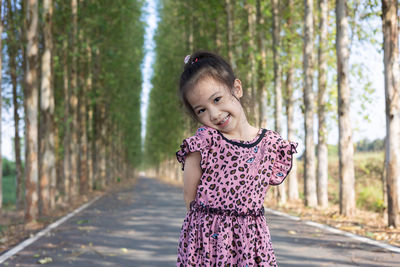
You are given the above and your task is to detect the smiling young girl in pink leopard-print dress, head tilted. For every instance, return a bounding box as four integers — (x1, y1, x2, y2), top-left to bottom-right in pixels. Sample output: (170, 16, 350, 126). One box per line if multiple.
(176, 52, 297, 266)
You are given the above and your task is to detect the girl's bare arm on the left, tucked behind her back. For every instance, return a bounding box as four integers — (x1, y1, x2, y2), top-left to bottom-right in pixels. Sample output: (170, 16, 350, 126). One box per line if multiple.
(183, 152, 203, 210)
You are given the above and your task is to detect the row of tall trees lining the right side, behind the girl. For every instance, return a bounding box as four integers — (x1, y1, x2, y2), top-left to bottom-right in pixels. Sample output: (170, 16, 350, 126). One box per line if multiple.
(145, 0, 400, 226)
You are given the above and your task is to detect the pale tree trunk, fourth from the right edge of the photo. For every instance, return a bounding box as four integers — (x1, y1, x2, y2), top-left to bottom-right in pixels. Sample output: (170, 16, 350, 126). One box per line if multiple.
(303, 0, 317, 207)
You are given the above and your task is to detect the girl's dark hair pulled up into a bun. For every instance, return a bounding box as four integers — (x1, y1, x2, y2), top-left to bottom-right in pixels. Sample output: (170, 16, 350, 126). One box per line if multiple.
(179, 51, 235, 120)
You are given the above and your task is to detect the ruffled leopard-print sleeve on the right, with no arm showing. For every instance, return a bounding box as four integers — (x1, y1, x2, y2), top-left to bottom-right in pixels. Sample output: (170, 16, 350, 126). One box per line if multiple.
(269, 138, 298, 185)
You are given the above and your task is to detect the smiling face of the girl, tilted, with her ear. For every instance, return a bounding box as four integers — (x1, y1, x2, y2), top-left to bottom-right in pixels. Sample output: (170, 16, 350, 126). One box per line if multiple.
(186, 77, 246, 135)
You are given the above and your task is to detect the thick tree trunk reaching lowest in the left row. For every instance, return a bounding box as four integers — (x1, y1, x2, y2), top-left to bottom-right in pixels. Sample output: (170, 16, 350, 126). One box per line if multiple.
(24, 0, 39, 222)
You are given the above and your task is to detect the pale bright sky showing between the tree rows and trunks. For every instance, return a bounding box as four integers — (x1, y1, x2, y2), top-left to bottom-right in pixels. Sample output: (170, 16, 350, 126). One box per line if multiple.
(1, 0, 386, 159)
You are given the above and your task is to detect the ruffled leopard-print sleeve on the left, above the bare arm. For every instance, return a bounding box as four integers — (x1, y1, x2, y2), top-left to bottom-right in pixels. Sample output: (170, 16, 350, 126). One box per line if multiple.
(176, 126, 212, 170)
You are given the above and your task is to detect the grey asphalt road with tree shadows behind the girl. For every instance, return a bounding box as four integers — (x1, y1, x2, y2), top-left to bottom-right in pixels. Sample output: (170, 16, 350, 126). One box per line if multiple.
(2, 177, 400, 267)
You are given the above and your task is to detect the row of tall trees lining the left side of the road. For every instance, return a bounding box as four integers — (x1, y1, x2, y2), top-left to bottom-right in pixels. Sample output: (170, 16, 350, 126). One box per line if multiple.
(0, 0, 144, 221)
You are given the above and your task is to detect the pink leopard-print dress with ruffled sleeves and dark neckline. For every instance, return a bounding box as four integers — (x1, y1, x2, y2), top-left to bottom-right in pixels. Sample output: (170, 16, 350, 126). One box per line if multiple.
(176, 126, 297, 266)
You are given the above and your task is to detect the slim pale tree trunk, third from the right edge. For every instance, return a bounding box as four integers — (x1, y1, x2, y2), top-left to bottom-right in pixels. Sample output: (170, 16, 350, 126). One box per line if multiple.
(317, 0, 328, 208)
